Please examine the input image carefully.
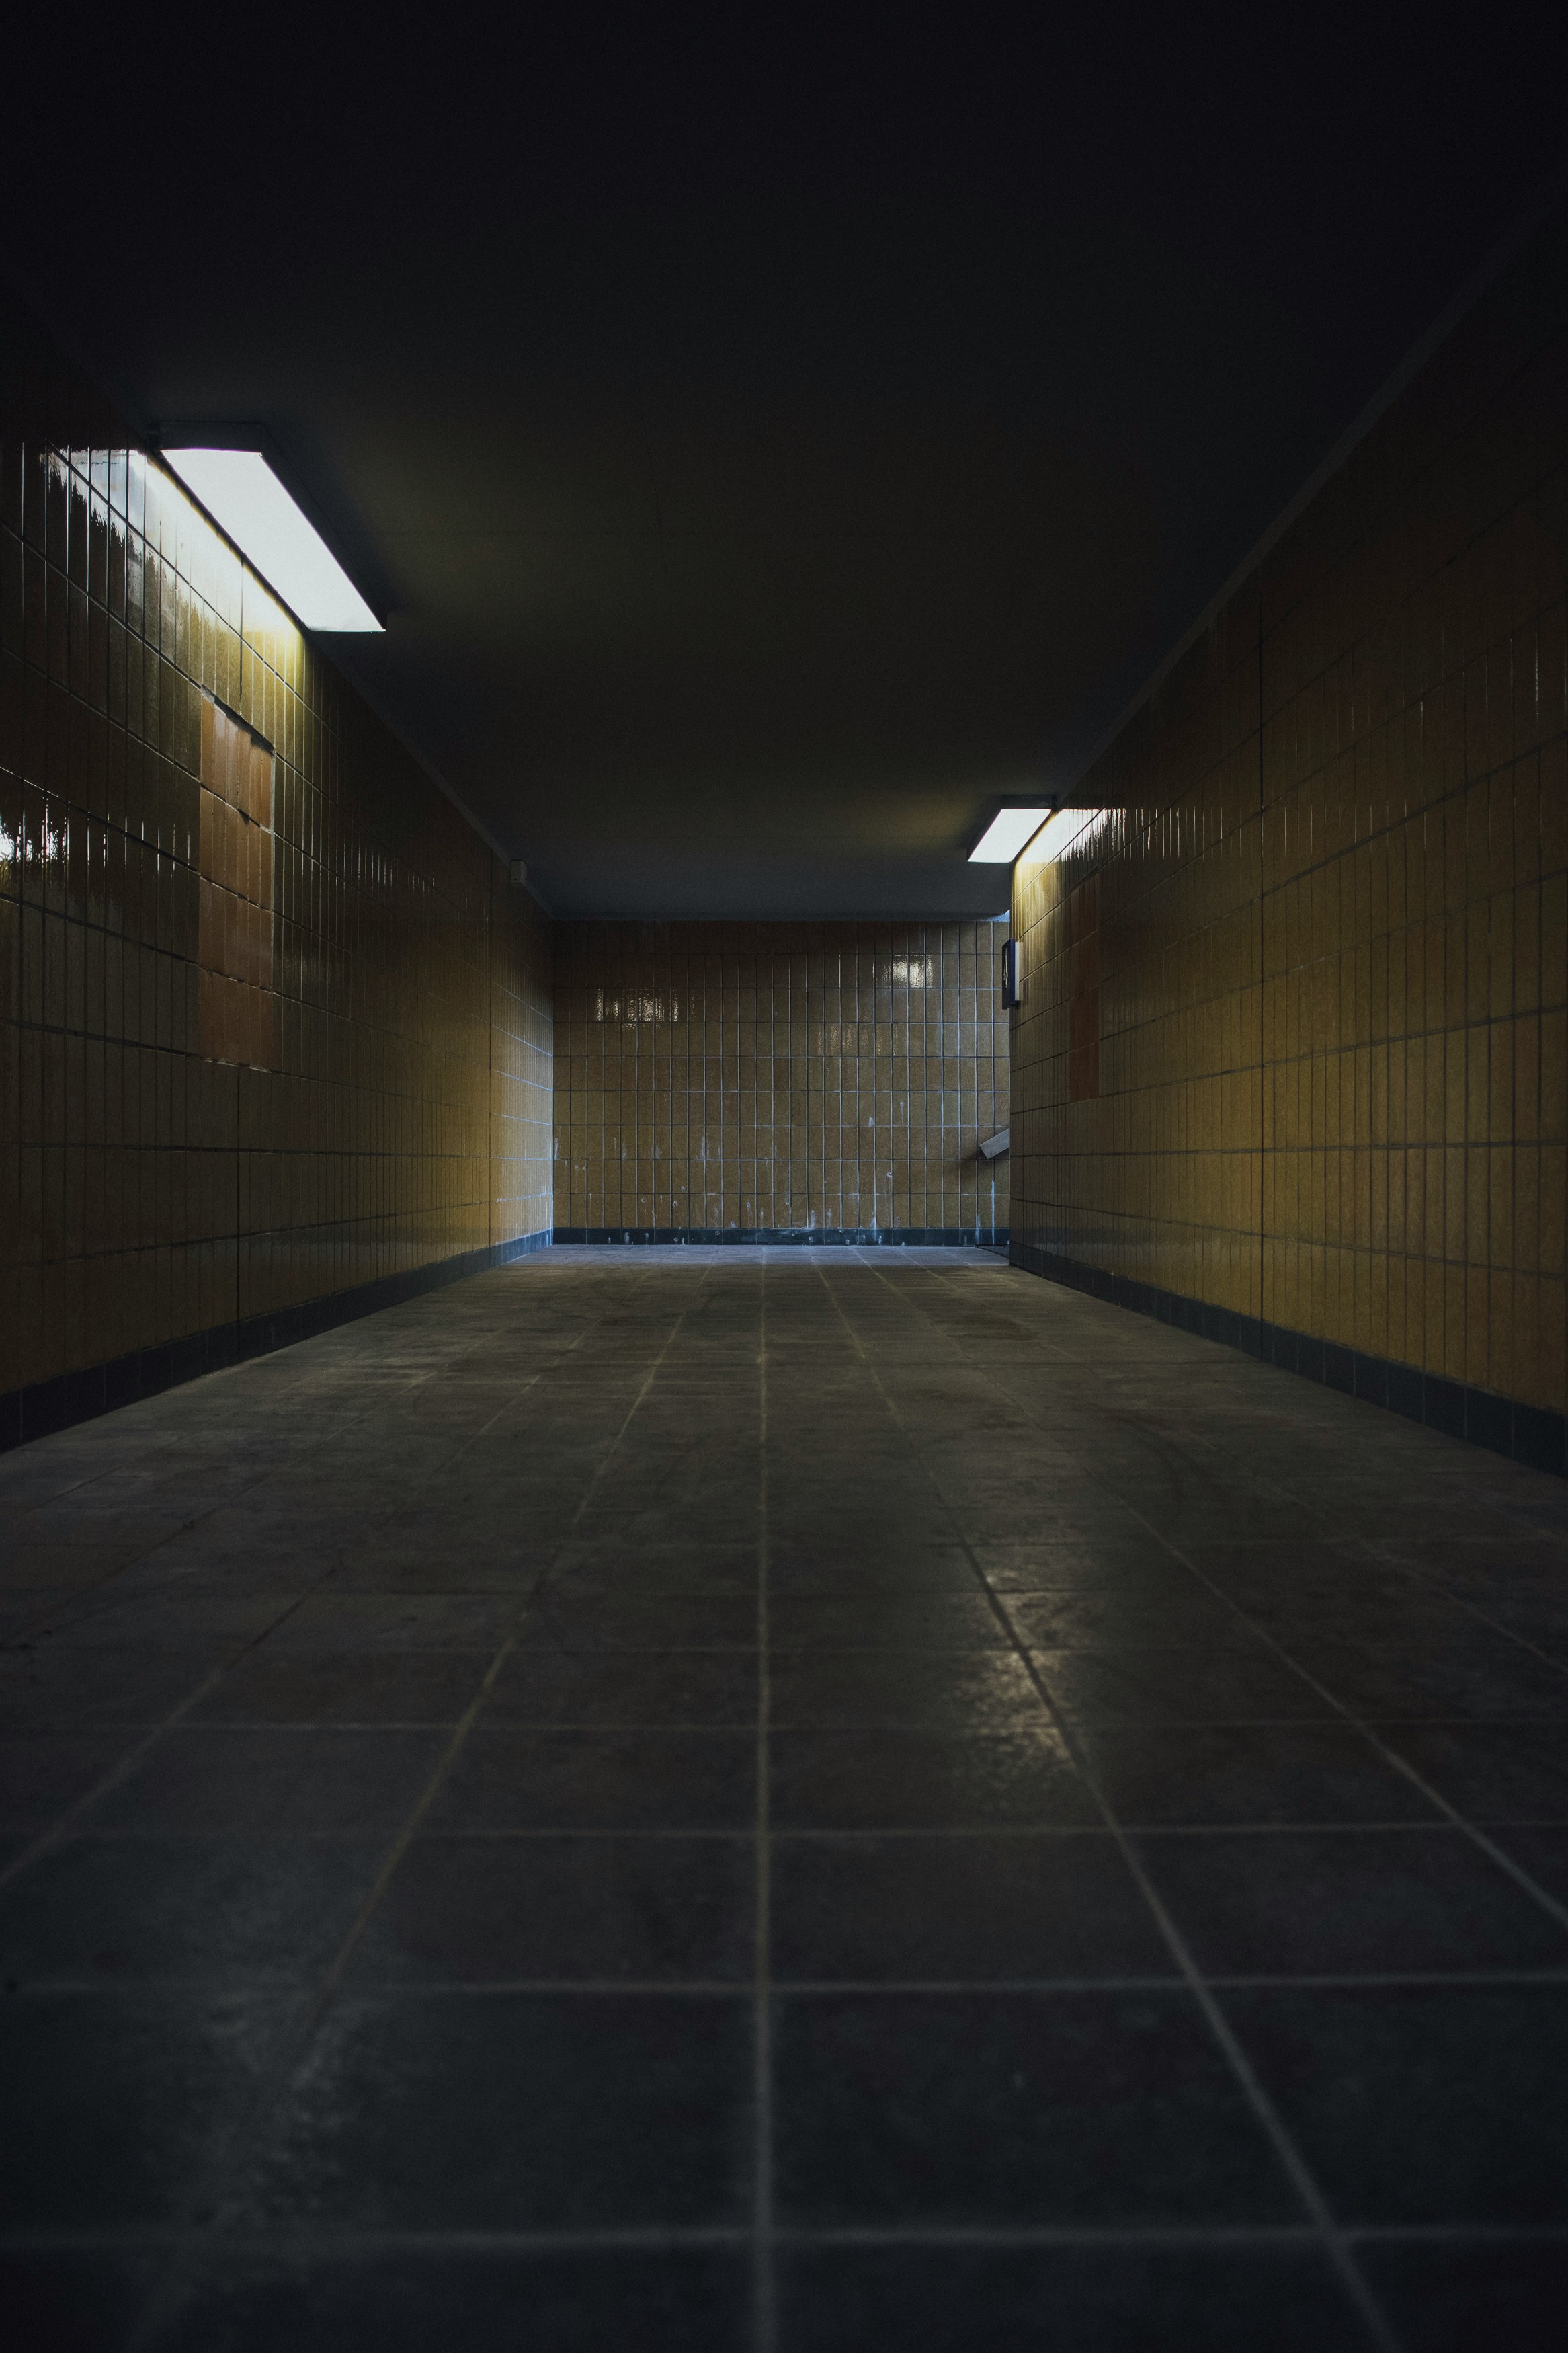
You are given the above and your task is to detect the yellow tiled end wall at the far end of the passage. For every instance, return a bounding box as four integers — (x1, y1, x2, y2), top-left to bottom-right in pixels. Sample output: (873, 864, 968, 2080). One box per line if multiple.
(554, 922, 1009, 1240)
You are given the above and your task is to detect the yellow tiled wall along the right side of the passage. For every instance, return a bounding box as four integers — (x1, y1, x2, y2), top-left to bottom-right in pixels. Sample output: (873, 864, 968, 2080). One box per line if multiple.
(1014, 214, 1568, 1464)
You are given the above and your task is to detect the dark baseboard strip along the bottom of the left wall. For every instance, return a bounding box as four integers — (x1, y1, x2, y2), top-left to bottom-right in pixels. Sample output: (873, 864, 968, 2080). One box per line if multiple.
(0, 1233, 550, 1454)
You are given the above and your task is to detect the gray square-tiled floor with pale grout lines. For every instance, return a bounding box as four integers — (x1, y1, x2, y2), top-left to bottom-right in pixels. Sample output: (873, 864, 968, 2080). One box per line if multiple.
(0, 1250, 1568, 2353)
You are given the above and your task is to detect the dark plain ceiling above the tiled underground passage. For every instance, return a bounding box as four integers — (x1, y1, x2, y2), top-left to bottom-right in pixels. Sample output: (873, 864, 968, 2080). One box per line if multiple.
(7, 12, 1559, 916)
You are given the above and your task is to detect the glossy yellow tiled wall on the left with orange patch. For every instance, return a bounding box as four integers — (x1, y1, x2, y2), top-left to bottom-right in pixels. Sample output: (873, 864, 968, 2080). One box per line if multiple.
(0, 294, 550, 1440)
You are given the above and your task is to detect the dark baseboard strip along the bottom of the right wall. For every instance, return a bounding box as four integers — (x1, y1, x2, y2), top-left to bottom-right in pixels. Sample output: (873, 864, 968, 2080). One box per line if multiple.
(1009, 1242, 1568, 1478)
